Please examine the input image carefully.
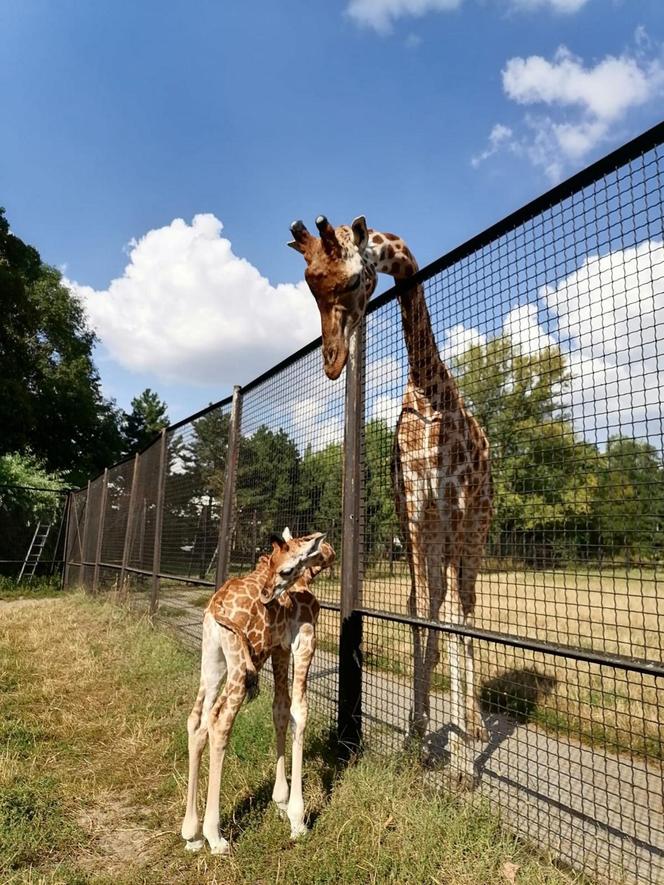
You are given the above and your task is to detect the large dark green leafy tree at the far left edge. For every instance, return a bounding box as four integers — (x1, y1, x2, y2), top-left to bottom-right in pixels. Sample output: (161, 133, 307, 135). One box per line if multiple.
(0, 209, 122, 483)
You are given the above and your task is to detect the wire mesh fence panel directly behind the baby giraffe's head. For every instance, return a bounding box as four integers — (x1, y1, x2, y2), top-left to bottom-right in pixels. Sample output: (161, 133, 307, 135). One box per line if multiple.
(231, 350, 344, 714)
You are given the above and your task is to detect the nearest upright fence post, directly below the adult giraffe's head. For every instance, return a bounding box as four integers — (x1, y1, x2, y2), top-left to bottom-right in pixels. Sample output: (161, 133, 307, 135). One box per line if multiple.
(337, 321, 364, 759)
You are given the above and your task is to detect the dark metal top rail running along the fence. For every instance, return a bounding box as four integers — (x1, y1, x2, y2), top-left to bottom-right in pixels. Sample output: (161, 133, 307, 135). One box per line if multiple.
(75, 121, 664, 479)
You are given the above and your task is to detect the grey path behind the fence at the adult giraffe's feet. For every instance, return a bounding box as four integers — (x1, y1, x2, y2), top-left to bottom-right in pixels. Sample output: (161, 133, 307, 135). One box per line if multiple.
(157, 595, 664, 885)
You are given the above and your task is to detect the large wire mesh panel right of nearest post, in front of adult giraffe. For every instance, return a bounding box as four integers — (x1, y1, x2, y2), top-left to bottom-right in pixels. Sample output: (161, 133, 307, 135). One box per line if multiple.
(362, 133, 664, 882)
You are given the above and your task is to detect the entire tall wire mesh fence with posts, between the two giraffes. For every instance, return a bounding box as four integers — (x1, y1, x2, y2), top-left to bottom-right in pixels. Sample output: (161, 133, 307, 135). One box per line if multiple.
(66, 124, 664, 883)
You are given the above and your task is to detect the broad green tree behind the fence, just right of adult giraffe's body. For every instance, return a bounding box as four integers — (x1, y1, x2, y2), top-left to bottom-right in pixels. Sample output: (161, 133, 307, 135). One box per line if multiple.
(454, 336, 599, 565)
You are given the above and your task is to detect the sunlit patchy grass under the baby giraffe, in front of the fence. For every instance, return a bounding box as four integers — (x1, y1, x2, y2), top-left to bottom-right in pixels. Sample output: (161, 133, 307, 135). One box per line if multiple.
(0, 594, 581, 885)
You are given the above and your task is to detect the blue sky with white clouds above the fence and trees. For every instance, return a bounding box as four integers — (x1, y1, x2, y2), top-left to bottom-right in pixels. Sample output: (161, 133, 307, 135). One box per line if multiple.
(0, 0, 664, 419)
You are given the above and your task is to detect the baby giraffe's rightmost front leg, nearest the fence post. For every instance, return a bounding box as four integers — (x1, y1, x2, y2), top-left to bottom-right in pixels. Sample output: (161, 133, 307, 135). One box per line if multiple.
(286, 624, 316, 839)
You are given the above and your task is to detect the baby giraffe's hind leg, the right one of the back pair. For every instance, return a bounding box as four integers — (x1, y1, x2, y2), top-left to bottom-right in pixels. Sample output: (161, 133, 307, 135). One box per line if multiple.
(203, 630, 247, 854)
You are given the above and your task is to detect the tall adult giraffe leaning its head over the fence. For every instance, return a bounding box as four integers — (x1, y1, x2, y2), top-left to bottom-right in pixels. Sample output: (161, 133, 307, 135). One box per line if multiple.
(289, 216, 492, 773)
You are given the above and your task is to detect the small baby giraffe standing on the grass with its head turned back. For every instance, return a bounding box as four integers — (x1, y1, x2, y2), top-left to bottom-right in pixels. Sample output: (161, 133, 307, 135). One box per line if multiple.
(182, 528, 334, 854)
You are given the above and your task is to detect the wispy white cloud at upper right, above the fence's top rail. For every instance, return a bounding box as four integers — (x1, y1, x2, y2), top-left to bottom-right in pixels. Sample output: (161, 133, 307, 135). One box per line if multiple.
(471, 39, 664, 181)
